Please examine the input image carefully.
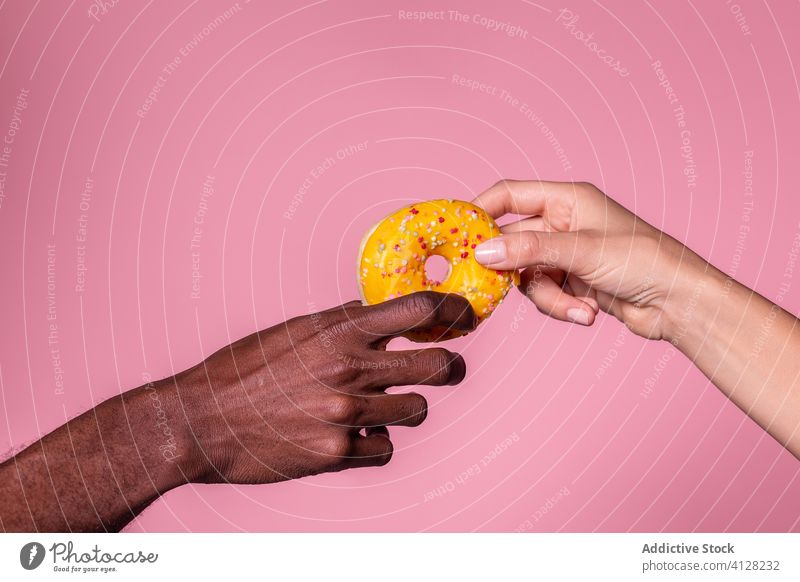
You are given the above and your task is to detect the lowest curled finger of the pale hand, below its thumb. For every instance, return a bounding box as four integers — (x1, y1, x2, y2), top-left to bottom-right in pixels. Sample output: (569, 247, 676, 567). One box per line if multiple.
(520, 267, 596, 325)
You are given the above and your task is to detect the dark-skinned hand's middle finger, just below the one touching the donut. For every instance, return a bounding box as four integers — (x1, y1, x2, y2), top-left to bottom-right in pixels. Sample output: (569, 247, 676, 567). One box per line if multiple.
(367, 348, 467, 390)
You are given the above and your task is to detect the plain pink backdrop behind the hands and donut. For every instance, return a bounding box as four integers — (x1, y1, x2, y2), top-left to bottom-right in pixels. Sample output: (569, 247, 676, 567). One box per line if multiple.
(0, 0, 800, 531)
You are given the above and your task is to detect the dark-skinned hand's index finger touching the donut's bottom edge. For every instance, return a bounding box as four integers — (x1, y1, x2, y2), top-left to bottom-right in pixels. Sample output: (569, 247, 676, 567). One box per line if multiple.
(357, 291, 478, 341)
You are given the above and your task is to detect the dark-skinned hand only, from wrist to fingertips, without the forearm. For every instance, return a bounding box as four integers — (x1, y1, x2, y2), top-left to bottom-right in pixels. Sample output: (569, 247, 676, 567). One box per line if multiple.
(176, 292, 476, 483)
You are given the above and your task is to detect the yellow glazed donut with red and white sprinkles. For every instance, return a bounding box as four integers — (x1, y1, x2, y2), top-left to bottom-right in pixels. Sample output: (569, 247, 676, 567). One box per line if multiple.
(357, 200, 519, 339)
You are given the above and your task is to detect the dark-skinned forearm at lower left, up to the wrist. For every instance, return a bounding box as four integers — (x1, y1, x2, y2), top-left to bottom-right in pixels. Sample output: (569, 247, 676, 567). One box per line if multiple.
(0, 380, 202, 531)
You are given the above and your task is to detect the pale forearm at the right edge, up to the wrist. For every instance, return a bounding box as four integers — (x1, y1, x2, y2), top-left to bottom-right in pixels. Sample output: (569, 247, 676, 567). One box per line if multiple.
(668, 267, 800, 458)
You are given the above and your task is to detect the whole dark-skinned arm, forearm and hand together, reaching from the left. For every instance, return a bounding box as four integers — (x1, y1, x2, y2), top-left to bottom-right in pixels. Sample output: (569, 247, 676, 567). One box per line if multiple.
(0, 293, 476, 531)
